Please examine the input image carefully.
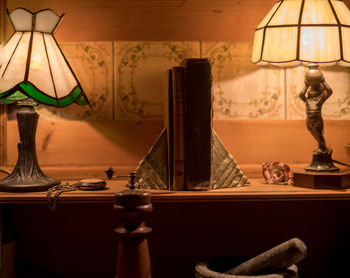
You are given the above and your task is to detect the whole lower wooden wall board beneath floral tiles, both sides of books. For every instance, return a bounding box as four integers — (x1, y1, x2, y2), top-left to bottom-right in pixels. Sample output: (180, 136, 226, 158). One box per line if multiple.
(7, 120, 350, 178)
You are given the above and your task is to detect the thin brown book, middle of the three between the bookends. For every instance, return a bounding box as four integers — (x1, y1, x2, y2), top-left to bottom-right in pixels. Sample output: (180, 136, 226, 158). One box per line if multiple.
(172, 67, 185, 191)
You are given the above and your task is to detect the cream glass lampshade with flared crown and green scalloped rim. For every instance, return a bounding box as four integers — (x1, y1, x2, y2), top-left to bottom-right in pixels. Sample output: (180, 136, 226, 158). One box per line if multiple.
(0, 8, 88, 107)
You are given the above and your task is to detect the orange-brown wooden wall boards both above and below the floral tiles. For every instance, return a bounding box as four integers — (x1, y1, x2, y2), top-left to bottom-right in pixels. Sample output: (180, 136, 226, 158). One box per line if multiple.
(4, 0, 350, 177)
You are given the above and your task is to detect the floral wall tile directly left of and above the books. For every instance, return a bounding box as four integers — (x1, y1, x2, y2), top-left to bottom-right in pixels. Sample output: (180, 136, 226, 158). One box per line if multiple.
(114, 42, 200, 120)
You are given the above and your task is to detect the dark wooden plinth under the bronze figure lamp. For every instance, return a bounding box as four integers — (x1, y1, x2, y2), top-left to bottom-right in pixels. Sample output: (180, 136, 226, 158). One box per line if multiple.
(293, 170, 350, 189)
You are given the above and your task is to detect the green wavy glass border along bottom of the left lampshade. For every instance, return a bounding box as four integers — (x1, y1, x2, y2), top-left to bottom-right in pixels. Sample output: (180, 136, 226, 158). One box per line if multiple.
(0, 82, 89, 107)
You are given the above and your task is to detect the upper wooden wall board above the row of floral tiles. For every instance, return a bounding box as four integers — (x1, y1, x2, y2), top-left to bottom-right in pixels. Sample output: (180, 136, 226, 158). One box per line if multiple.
(8, 0, 276, 41)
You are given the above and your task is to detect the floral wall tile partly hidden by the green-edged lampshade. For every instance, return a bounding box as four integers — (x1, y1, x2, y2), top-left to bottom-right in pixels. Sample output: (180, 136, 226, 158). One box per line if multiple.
(38, 42, 114, 120)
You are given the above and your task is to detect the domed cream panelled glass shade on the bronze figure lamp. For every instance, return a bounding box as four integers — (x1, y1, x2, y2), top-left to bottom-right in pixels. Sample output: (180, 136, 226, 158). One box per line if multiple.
(252, 0, 350, 66)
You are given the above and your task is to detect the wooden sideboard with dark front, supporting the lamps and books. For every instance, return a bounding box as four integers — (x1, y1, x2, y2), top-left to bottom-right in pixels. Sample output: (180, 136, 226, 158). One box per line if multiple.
(0, 179, 350, 278)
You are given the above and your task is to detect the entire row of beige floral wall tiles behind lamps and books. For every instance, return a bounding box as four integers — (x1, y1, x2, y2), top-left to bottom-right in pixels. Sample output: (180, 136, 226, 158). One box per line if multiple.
(34, 41, 350, 121)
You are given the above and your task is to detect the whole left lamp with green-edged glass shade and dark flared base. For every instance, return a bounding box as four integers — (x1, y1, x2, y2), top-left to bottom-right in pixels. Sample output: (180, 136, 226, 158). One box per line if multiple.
(0, 8, 89, 191)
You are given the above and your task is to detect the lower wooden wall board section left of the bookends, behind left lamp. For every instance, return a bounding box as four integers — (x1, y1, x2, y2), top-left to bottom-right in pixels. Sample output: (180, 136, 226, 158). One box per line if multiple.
(7, 118, 163, 167)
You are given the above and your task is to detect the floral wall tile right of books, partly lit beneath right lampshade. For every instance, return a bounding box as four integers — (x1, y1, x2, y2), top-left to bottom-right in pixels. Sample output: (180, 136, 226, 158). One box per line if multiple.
(202, 42, 285, 119)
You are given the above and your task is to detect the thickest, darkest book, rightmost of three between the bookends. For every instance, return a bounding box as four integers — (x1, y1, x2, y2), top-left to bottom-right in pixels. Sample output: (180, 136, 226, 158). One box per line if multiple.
(184, 58, 212, 190)
